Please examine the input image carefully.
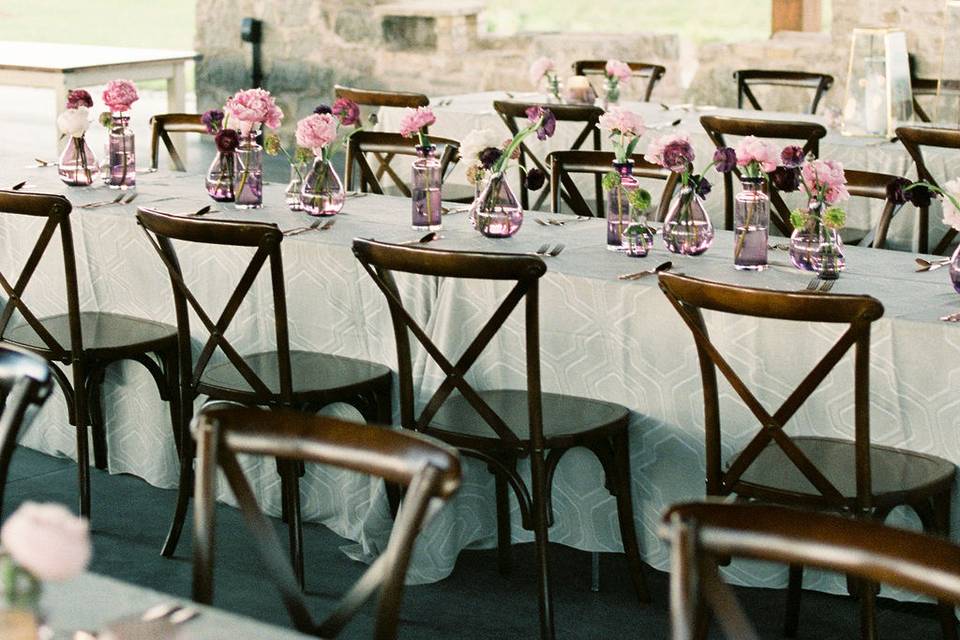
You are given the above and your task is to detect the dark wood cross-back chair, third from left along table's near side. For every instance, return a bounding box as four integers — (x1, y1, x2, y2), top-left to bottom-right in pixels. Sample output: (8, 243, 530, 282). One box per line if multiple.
(353, 240, 649, 639)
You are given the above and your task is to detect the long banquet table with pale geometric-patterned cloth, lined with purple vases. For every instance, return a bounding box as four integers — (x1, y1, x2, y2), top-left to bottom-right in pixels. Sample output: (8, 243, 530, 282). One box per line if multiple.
(0, 160, 960, 590)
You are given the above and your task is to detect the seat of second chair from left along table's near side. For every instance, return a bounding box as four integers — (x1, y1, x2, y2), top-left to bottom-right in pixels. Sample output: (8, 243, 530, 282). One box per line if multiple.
(198, 351, 391, 401)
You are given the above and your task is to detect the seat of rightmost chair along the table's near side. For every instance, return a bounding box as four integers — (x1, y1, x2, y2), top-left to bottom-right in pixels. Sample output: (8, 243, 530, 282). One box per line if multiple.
(735, 437, 956, 507)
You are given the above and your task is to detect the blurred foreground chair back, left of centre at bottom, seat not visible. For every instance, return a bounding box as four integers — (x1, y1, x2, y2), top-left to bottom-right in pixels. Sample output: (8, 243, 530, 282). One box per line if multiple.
(193, 407, 460, 640)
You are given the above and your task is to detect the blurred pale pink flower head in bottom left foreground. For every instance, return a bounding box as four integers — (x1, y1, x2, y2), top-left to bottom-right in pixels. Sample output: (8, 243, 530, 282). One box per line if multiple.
(0, 502, 91, 582)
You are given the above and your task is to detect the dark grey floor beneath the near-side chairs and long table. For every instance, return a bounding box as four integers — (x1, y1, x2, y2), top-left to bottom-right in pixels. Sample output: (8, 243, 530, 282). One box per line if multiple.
(6, 448, 940, 640)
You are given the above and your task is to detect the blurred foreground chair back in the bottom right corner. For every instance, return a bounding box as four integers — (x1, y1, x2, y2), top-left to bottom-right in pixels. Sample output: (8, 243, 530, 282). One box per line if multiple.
(661, 502, 960, 640)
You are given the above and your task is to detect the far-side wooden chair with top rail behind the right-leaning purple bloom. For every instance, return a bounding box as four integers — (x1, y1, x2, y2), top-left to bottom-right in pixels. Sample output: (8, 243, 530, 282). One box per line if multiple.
(493, 100, 603, 210)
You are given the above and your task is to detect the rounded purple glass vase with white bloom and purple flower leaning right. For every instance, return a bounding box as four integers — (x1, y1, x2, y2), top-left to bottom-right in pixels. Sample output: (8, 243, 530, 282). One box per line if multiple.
(470, 105, 557, 238)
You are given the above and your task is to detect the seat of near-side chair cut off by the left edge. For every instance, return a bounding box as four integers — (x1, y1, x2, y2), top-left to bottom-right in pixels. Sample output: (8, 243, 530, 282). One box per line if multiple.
(3, 311, 177, 357)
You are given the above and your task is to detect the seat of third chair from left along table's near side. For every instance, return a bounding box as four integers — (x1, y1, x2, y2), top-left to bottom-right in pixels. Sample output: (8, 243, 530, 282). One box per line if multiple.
(424, 389, 630, 449)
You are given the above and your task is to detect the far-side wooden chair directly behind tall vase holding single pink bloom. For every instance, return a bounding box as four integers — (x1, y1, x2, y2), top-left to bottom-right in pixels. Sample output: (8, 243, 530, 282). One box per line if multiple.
(345, 131, 460, 198)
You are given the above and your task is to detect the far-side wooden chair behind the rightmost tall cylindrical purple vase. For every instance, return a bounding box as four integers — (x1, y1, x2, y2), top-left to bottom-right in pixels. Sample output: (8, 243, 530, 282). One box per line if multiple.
(700, 116, 827, 237)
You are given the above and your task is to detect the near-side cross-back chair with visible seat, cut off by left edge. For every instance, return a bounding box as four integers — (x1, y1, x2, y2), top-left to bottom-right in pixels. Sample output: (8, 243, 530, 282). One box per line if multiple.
(0, 191, 180, 518)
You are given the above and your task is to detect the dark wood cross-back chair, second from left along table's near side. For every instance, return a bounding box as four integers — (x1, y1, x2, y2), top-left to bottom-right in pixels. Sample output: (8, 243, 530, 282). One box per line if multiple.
(137, 208, 392, 580)
